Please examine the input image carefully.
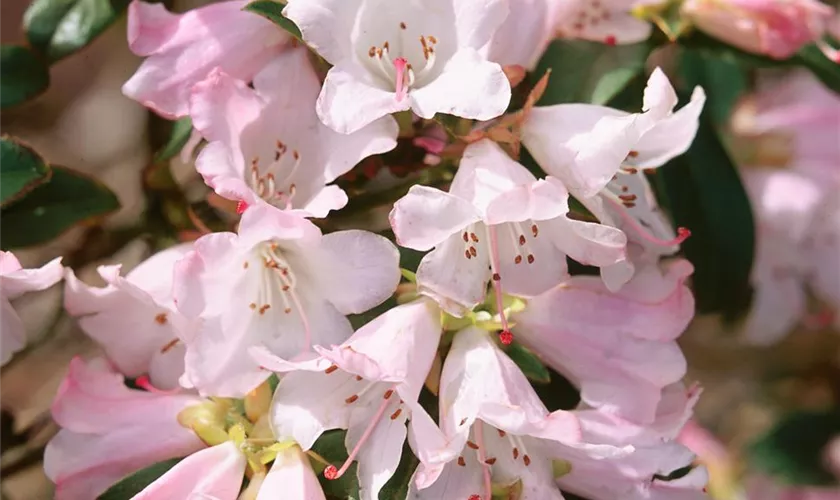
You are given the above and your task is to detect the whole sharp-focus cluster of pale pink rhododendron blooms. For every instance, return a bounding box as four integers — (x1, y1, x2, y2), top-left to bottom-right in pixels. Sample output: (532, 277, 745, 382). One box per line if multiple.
(0, 0, 728, 500)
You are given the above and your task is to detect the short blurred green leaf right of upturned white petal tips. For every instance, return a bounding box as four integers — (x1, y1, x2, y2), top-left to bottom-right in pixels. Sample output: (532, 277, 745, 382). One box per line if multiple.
(680, 49, 747, 124)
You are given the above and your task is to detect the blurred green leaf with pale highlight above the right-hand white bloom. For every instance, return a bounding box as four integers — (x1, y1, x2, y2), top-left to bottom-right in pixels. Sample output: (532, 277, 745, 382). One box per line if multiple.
(534, 40, 652, 106)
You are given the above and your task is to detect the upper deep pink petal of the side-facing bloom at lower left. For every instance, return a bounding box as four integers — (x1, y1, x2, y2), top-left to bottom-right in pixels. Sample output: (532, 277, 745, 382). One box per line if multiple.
(51, 358, 201, 434)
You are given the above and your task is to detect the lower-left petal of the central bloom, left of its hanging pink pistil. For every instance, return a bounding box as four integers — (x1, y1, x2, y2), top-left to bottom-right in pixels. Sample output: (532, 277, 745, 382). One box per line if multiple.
(417, 234, 491, 317)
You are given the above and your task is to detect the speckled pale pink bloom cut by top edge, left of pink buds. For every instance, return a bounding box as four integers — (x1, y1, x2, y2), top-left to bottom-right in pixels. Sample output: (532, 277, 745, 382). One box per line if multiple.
(551, 0, 651, 45)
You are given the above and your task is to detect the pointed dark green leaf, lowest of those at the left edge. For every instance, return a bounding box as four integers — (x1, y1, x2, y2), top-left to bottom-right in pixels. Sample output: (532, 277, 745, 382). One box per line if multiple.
(0, 166, 120, 249)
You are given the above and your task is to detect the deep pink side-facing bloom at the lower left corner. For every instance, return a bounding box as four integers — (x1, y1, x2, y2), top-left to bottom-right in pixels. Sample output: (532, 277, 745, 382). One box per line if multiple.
(44, 358, 205, 500)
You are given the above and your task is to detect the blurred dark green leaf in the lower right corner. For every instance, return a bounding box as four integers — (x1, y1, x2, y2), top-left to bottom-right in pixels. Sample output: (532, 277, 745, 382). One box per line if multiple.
(748, 408, 840, 486)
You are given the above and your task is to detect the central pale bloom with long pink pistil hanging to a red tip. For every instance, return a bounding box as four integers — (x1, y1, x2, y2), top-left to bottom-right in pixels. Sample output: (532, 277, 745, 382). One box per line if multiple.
(390, 139, 626, 316)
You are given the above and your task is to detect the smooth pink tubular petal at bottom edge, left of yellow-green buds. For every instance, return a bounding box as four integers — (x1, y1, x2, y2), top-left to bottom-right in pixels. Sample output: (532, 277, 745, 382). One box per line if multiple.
(133, 441, 247, 500)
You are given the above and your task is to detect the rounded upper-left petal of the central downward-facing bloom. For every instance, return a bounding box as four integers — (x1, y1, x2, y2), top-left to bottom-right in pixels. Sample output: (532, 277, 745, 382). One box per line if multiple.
(389, 185, 480, 250)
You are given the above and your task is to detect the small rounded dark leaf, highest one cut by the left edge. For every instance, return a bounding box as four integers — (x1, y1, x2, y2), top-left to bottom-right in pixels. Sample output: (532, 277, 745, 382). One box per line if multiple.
(0, 45, 50, 109)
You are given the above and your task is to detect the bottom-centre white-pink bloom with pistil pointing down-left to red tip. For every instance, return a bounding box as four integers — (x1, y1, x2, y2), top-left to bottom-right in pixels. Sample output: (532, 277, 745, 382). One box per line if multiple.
(270, 299, 446, 500)
